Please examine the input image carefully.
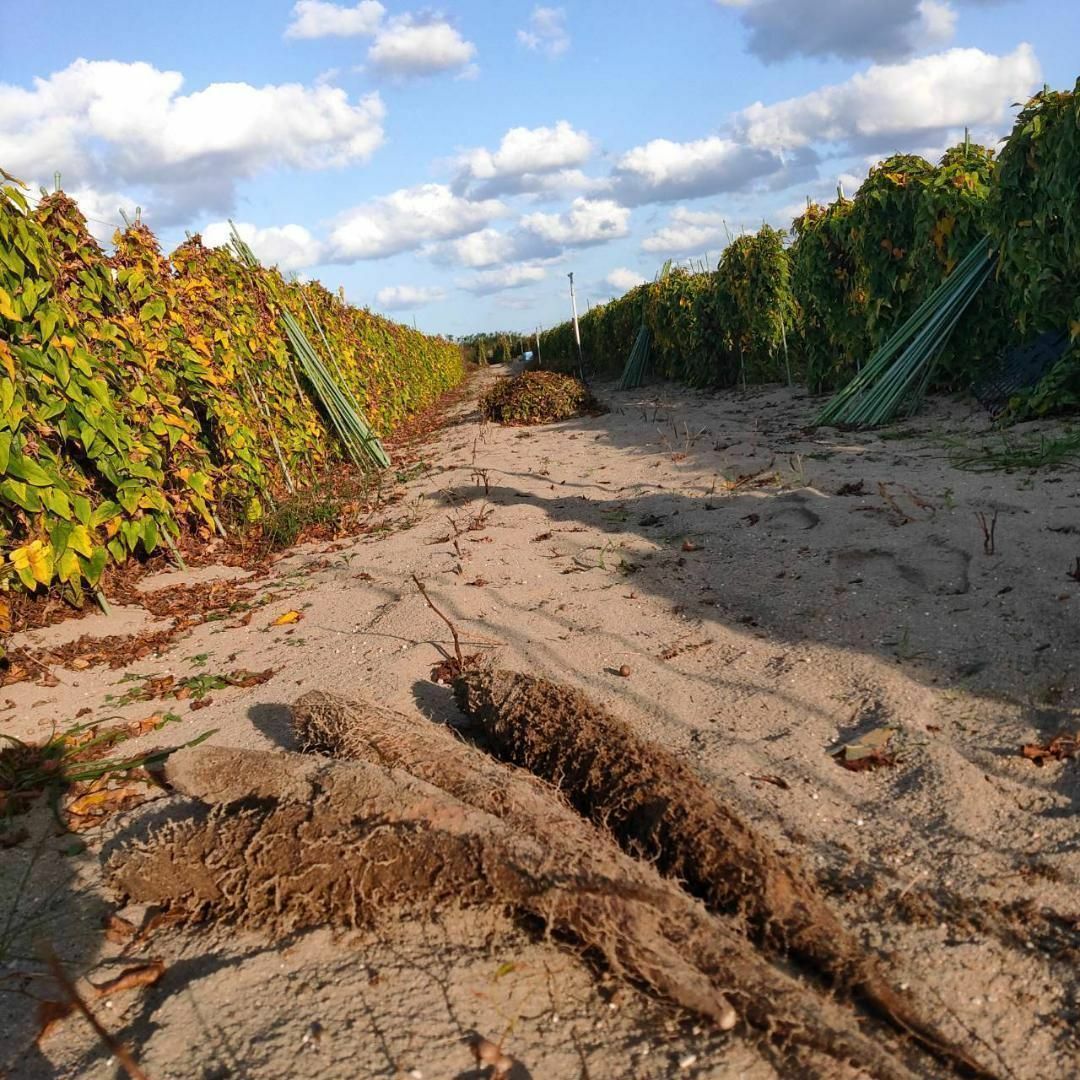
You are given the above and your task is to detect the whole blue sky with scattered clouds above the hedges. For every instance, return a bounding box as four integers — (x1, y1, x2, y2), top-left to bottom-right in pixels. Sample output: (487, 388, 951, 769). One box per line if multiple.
(0, 0, 1080, 334)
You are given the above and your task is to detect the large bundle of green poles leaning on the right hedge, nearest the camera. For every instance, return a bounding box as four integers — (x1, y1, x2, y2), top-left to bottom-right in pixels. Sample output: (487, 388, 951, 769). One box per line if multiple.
(814, 239, 994, 428)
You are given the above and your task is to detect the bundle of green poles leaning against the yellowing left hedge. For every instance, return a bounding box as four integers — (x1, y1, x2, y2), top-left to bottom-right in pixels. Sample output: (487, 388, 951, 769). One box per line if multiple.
(229, 221, 390, 469)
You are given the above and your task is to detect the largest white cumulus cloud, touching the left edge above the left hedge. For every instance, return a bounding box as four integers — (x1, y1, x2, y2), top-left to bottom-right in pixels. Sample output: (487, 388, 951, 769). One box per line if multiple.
(0, 59, 386, 225)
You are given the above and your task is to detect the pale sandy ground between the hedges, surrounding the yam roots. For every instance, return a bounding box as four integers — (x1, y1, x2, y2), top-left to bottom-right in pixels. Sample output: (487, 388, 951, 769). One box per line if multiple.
(0, 372, 1080, 1078)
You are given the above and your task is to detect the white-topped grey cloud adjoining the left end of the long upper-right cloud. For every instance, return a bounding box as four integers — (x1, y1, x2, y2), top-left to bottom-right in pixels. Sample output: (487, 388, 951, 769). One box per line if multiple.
(615, 135, 781, 204)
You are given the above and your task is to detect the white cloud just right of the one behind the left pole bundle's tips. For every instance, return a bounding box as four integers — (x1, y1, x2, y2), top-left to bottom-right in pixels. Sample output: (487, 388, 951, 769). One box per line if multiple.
(329, 184, 508, 261)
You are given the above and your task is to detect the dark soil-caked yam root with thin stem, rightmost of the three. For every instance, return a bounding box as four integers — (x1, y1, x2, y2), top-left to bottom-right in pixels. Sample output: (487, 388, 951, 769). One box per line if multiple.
(455, 671, 993, 1076)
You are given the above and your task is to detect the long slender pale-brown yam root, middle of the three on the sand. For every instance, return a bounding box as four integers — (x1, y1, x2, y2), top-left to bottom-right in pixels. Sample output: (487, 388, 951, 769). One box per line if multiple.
(293, 690, 920, 1077)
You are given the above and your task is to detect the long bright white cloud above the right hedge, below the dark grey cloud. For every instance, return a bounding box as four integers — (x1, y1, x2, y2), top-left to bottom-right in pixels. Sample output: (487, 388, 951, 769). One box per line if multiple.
(739, 44, 1040, 149)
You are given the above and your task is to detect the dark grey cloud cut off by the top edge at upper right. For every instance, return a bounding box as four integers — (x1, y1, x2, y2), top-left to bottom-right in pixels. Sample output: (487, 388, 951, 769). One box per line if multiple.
(716, 0, 994, 63)
